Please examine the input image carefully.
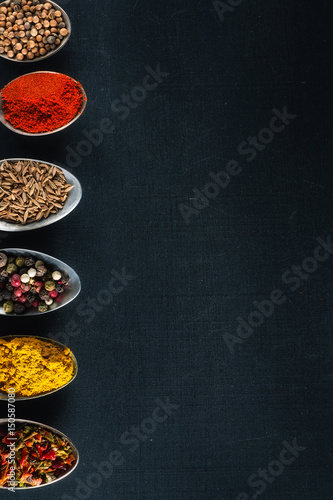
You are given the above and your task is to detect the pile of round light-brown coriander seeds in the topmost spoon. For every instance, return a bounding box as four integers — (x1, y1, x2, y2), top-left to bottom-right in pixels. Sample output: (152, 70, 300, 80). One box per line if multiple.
(0, 0, 69, 61)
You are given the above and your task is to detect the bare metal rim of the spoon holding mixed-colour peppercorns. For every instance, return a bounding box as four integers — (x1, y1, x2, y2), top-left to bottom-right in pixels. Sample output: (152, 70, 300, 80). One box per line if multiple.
(0, 248, 81, 317)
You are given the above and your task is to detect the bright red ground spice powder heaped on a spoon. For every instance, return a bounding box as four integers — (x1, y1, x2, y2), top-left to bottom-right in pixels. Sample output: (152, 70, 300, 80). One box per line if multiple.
(1, 73, 83, 133)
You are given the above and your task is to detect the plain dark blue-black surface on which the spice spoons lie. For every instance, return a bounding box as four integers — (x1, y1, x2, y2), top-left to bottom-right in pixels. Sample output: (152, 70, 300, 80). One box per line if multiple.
(0, 0, 333, 500)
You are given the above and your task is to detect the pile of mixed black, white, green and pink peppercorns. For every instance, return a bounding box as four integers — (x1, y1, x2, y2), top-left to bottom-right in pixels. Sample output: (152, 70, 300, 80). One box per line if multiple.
(0, 252, 69, 314)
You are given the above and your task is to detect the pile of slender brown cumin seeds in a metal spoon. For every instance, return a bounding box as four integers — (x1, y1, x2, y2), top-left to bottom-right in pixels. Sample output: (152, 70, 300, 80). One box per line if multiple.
(0, 160, 74, 224)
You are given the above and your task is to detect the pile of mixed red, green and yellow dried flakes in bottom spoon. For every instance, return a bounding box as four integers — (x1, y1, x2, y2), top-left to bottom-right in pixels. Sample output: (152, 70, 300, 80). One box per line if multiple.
(0, 424, 75, 488)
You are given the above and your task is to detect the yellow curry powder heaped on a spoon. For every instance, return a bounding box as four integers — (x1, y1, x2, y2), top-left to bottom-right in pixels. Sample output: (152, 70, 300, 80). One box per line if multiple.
(0, 337, 74, 396)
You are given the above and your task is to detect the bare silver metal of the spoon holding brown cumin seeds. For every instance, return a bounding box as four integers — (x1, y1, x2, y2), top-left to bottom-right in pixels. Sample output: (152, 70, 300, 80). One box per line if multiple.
(0, 158, 82, 232)
